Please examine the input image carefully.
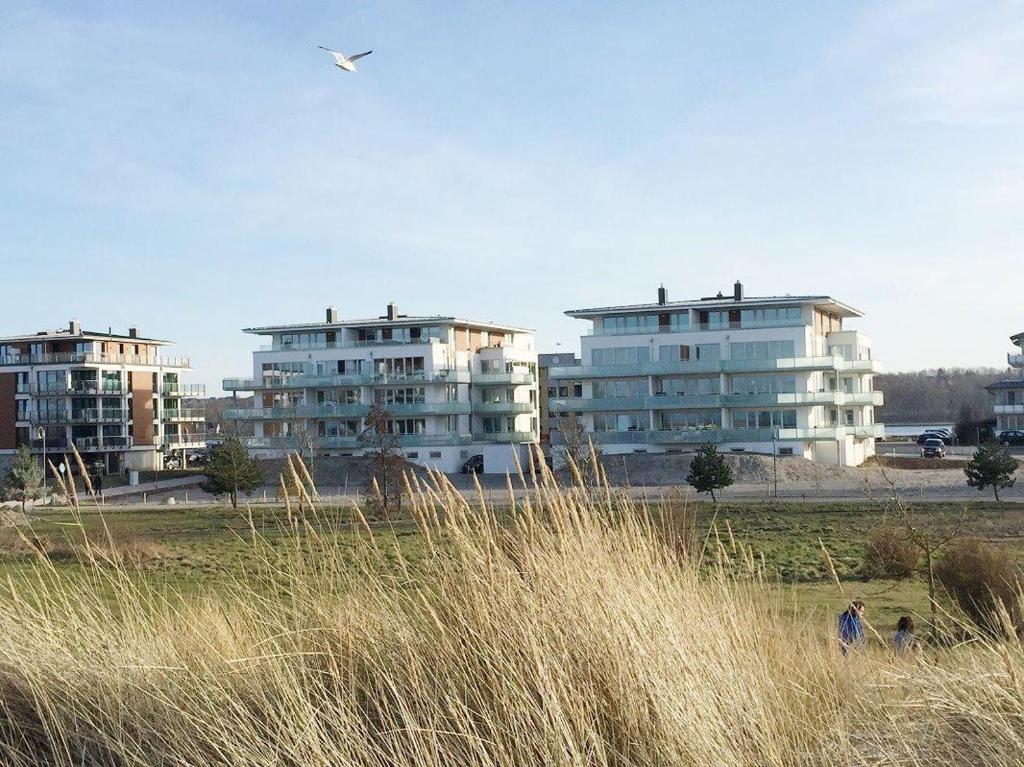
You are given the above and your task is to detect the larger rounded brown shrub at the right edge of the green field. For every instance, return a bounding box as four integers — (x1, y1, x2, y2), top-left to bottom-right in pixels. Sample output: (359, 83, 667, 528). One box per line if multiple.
(935, 539, 1020, 633)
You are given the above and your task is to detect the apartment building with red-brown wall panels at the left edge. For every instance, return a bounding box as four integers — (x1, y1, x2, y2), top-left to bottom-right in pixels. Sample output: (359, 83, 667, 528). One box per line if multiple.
(0, 321, 206, 473)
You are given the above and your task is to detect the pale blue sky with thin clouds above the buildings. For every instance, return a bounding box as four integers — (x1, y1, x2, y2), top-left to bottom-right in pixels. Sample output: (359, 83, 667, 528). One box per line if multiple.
(0, 0, 1024, 390)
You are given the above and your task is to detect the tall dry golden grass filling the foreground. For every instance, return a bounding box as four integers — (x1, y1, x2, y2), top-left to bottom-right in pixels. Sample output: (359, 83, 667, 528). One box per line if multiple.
(0, 452, 1024, 767)
